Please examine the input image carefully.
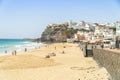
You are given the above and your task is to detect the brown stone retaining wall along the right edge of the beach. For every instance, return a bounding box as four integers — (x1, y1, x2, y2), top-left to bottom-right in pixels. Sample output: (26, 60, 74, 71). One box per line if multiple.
(93, 48, 120, 80)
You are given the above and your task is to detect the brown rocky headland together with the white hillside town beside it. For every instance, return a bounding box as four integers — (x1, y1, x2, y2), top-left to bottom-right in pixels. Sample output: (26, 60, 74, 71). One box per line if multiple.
(41, 21, 120, 48)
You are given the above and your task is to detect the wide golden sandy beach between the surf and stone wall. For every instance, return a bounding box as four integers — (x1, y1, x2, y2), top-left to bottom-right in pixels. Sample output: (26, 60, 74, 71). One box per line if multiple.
(0, 43, 109, 80)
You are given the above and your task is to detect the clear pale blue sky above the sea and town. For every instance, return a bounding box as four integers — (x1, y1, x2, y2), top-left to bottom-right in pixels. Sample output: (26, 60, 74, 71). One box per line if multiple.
(0, 0, 120, 38)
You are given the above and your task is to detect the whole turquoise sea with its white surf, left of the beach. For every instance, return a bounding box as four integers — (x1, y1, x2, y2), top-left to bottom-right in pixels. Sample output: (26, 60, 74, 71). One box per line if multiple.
(0, 39, 42, 56)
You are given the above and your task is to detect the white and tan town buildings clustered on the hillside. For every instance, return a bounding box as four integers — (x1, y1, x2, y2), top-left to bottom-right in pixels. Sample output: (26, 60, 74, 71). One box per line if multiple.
(70, 22, 120, 47)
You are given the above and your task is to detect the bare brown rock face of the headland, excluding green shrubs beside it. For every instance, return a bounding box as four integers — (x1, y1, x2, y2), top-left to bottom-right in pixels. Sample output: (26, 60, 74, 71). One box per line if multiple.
(41, 23, 68, 42)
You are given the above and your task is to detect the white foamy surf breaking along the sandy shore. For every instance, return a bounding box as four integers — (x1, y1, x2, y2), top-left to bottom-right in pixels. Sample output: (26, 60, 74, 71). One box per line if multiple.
(0, 42, 43, 53)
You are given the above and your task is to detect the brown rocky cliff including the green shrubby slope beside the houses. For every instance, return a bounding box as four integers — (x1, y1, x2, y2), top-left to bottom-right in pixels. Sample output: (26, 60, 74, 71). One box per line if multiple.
(41, 23, 78, 42)
